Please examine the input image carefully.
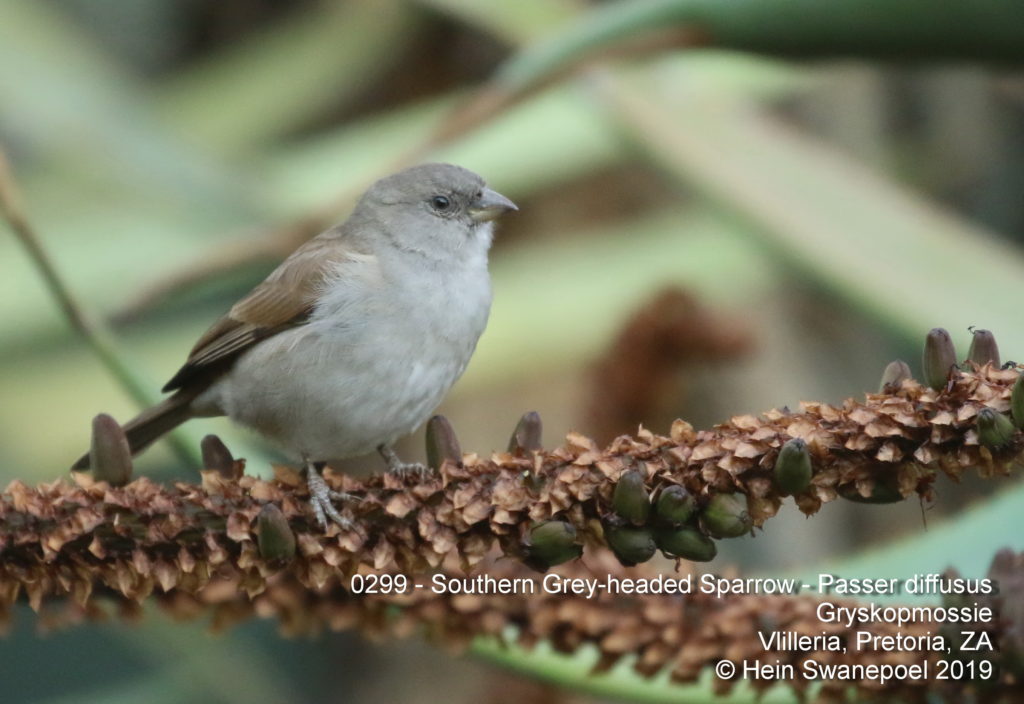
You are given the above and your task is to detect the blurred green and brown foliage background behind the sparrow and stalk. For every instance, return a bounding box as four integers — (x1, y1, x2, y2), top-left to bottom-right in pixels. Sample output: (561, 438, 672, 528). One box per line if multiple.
(0, 0, 1024, 704)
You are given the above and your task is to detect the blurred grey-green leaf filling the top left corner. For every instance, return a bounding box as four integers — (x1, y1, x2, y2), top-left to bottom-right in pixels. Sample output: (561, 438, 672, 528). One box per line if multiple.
(0, 0, 254, 210)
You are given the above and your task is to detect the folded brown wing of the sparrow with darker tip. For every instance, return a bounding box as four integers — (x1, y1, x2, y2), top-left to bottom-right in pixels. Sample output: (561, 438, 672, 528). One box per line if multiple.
(164, 236, 345, 391)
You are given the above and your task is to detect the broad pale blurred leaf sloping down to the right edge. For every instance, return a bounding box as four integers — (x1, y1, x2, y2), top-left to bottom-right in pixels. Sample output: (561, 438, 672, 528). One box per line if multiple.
(600, 74, 1024, 354)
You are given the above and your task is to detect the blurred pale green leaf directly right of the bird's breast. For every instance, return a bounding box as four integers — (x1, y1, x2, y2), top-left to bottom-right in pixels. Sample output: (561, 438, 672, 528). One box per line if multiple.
(458, 210, 775, 393)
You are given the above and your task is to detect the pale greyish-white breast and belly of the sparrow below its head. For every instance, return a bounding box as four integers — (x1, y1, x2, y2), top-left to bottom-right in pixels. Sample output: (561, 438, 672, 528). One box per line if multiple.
(197, 239, 490, 460)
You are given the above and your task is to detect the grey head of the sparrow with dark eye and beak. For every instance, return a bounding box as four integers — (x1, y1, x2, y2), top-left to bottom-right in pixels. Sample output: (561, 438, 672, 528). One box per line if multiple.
(353, 164, 518, 260)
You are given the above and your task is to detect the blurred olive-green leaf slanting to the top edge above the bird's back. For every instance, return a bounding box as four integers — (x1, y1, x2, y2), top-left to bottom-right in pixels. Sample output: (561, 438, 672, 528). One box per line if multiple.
(155, 0, 419, 155)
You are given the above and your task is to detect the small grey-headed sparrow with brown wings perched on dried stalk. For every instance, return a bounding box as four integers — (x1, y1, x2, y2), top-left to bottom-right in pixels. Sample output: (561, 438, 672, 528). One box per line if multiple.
(72, 164, 518, 530)
